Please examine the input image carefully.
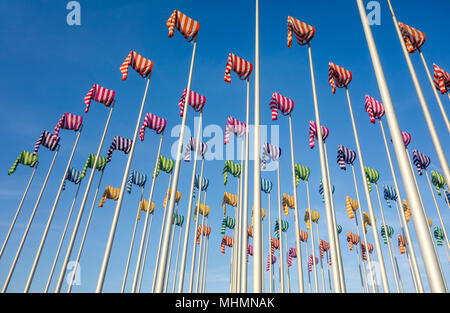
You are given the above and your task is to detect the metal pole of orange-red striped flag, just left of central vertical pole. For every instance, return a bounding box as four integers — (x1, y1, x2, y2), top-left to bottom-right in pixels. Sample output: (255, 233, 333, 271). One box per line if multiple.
(241, 78, 251, 293)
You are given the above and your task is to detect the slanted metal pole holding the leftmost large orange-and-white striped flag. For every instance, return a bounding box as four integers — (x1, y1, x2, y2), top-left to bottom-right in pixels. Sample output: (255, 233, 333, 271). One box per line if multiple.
(95, 74, 151, 293)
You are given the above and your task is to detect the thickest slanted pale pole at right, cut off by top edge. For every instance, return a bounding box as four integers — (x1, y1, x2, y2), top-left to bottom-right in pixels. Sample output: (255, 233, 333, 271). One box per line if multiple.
(356, 0, 449, 292)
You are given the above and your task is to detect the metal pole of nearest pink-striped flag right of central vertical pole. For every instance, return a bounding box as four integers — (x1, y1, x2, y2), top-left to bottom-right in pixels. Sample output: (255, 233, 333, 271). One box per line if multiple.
(289, 114, 304, 293)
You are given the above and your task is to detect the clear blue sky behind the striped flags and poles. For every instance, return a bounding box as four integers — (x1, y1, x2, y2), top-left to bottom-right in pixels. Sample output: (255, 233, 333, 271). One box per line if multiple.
(0, 0, 450, 292)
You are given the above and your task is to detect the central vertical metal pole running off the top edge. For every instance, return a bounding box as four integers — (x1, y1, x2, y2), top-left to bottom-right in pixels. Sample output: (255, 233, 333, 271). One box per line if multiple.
(253, 0, 264, 293)
